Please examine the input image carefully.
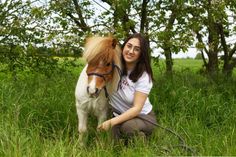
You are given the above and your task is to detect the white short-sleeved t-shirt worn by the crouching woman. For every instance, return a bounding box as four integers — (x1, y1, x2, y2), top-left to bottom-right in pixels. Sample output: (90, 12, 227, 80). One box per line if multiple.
(110, 72, 152, 114)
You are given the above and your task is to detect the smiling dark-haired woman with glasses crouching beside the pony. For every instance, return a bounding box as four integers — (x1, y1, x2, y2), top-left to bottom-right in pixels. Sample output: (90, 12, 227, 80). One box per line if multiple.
(98, 33, 156, 139)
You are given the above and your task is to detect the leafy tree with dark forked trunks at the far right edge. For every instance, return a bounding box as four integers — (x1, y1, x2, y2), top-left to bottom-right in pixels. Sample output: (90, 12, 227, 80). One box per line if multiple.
(189, 0, 236, 76)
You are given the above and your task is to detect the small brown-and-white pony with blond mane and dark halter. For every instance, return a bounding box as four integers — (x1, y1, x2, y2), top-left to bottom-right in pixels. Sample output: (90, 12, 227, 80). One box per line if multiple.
(75, 37, 121, 144)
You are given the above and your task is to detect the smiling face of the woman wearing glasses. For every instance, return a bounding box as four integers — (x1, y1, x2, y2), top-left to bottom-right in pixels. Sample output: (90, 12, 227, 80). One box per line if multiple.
(122, 38, 141, 64)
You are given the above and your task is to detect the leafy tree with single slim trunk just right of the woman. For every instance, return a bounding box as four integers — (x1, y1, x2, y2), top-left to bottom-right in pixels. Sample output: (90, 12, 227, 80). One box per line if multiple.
(150, 0, 194, 74)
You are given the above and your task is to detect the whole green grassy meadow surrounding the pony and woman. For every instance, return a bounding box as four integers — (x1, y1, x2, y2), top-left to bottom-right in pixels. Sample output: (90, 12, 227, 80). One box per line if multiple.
(0, 59, 236, 157)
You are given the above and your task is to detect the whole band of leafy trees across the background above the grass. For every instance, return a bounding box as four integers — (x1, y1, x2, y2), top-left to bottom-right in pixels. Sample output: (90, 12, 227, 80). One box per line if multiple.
(0, 0, 236, 79)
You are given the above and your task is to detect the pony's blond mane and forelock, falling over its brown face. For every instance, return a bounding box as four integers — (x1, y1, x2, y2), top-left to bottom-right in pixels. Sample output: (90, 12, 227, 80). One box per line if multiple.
(83, 36, 122, 93)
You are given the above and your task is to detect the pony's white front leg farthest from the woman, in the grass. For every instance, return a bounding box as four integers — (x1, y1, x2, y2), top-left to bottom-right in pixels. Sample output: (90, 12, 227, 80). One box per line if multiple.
(77, 108, 88, 145)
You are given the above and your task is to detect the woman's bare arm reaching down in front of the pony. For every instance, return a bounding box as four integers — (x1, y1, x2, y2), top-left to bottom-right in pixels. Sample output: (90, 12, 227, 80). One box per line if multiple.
(97, 91, 148, 130)
